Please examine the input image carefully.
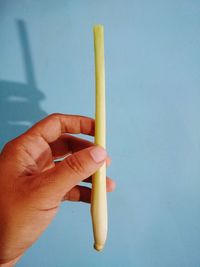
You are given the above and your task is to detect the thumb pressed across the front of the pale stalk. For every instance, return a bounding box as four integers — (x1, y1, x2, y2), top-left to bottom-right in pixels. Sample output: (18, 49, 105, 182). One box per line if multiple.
(34, 146, 107, 201)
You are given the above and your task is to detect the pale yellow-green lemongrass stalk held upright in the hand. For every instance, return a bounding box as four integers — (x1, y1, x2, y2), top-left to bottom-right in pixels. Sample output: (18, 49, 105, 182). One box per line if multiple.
(91, 25, 107, 251)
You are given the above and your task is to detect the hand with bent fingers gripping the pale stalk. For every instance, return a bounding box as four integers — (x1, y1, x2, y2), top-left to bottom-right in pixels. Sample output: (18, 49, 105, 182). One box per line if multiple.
(0, 114, 115, 266)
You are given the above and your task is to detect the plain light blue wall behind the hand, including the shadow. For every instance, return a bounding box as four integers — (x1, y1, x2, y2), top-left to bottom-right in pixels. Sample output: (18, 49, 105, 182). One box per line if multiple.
(0, 0, 200, 267)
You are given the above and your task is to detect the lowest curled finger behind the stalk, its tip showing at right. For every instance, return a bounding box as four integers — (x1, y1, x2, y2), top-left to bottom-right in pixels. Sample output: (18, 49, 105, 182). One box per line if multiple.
(62, 179, 114, 203)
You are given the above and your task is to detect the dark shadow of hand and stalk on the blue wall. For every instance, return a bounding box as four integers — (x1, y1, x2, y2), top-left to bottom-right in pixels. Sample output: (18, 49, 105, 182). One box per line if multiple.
(0, 20, 47, 150)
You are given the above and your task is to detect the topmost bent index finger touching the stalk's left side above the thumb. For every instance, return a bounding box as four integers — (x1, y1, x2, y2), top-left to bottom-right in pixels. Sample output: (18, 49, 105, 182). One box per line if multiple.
(26, 113, 95, 143)
